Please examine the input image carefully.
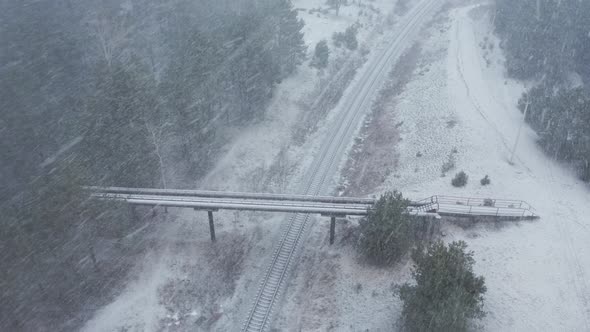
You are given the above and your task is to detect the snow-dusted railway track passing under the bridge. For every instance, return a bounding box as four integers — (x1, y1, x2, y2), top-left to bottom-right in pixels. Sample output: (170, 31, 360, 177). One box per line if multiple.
(242, 0, 436, 332)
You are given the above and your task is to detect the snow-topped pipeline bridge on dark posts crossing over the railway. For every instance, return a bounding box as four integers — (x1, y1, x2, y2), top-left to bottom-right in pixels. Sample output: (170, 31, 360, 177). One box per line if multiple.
(85, 187, 538, 244)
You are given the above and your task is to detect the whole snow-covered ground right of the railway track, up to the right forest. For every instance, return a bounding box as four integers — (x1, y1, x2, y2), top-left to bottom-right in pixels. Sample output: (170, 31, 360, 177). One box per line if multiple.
(278, 1, 590, 331)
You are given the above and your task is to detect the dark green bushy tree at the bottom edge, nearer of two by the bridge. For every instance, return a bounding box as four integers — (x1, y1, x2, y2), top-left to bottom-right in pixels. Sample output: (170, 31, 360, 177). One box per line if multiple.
(399, 241, 487, 331)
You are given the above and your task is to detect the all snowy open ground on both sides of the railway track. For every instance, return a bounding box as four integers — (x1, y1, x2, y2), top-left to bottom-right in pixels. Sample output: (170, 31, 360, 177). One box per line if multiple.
(80, 0, 590, 331)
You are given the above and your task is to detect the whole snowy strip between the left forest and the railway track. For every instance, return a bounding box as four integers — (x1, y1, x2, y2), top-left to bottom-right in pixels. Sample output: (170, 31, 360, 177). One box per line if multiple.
(85, 0, 408, 331)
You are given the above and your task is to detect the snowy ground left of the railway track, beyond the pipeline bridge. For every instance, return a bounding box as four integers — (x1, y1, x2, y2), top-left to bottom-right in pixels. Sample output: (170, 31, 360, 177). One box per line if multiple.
(197, 0, 396, 192)
